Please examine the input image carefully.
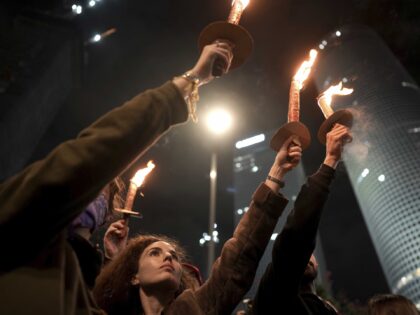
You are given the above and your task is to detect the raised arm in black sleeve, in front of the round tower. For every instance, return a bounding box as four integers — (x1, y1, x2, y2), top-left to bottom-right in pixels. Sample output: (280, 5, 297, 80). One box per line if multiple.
(254, 125, 350, 314)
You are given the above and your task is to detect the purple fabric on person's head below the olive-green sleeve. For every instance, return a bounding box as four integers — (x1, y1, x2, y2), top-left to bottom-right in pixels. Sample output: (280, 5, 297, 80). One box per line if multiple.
(70, 194, 108, 232)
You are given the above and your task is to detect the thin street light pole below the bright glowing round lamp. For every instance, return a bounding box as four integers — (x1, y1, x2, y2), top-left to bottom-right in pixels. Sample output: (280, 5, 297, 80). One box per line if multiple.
(207, 150, 217, 276)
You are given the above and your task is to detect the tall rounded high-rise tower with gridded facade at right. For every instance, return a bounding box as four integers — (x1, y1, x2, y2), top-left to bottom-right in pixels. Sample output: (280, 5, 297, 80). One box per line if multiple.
(314, 26, 420, 306)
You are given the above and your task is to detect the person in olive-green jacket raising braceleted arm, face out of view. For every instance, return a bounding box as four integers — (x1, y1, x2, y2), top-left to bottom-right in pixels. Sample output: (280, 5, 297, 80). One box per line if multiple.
(0, 43, 232, 315)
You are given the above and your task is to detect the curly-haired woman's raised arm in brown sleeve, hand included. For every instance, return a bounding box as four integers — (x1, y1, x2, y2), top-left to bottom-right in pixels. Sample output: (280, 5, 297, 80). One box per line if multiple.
(196, 138, 301, 314)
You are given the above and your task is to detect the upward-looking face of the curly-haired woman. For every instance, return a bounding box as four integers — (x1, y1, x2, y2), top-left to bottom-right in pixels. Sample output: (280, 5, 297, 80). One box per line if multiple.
(132, 241, 182, 292)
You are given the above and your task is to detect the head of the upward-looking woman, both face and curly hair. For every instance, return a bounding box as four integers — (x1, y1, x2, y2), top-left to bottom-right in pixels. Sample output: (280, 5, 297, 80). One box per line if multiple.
(94, 235, 194, 314)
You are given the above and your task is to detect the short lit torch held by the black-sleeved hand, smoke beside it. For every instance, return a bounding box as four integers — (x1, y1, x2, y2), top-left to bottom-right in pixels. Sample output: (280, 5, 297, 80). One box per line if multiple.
(318, 82, 353, 144)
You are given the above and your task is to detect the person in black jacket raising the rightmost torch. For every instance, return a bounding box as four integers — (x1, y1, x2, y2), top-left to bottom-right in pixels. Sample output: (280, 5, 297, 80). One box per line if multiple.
(253, 125, 351, 315)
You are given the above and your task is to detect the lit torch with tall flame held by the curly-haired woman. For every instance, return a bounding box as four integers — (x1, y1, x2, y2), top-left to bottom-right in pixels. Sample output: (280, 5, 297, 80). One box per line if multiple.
(270, 49, 318, 152)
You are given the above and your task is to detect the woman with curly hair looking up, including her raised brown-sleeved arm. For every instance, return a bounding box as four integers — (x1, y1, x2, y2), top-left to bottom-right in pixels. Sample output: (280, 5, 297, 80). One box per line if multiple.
(94, 137, 301, 315)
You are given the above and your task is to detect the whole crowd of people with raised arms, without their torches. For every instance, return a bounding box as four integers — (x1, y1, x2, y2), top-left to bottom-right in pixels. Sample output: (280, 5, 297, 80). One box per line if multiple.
(0, 41, 419, 315)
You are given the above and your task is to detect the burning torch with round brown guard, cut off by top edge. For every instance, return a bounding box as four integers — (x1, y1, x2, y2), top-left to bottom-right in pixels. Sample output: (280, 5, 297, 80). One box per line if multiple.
(198, 0, 254, 77)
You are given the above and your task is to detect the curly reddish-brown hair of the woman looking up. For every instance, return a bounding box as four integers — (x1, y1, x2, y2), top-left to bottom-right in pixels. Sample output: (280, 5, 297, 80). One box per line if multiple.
(93, 235, 195, 315)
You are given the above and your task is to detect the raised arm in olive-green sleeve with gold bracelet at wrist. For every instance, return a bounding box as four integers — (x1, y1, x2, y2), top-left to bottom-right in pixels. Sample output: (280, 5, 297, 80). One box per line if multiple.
(0, 44, 231, 267)
